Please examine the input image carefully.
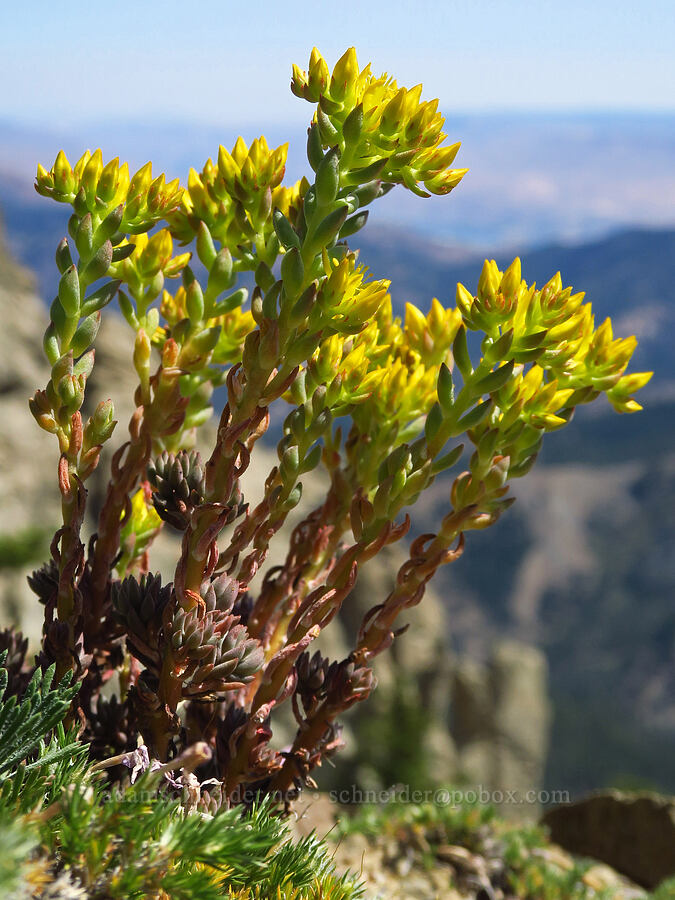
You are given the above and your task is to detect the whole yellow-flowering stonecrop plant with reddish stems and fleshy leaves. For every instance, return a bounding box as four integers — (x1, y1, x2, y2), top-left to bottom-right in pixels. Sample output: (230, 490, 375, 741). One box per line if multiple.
(23, 49, 649, 806)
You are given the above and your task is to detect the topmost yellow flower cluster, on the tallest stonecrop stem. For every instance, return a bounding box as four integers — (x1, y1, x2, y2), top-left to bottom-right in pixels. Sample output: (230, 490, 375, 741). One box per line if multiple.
(291, 47, 468, 197)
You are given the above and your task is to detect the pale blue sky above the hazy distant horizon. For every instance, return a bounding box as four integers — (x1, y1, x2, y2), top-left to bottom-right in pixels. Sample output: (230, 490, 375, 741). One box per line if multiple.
(0, 0, 675, 130)
